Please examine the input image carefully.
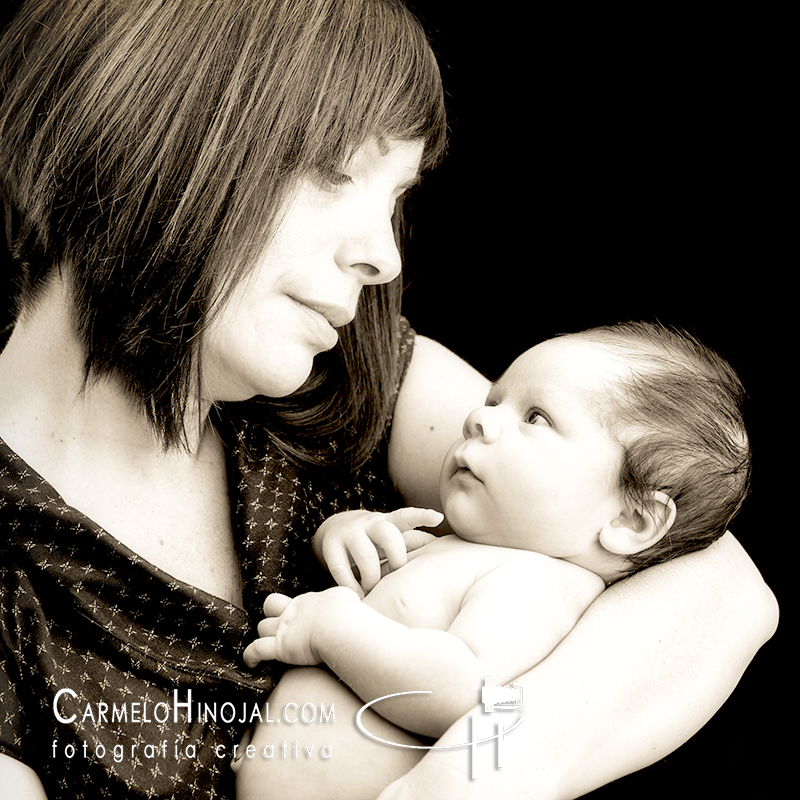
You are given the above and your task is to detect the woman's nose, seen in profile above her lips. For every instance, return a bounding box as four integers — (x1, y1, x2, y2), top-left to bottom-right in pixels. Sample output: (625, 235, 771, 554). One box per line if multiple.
(337, 206, 402, 284)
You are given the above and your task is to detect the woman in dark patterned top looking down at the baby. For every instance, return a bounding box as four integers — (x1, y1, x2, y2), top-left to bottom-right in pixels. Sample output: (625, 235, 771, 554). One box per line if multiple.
(0, 0, 775, 798)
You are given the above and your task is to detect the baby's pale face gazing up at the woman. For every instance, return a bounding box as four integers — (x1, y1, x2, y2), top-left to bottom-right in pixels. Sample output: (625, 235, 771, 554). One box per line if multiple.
(440, 338, 623, 558)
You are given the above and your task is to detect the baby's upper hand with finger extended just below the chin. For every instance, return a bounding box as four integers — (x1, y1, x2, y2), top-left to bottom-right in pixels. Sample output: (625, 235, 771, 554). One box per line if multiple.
(314, 508, 444, 597)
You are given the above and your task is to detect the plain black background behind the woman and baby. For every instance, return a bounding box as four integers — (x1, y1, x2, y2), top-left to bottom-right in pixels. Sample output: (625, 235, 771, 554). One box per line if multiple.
(405, 0, 797, 800)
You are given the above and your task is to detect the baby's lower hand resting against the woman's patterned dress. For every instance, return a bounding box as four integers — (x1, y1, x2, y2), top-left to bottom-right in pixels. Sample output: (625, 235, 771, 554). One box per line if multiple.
(244, 586, 361, 668)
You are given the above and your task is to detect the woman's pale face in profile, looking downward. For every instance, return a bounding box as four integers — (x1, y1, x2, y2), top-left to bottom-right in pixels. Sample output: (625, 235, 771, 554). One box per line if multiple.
(203, 140, 423, 402)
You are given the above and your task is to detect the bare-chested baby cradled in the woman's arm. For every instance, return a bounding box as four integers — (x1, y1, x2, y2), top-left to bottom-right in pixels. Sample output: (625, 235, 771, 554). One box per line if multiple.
(231, 323, 750, 797)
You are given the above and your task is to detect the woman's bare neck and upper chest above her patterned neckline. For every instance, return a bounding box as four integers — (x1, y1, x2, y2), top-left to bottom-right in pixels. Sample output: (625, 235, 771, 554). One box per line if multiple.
(0, 283, 241, 605)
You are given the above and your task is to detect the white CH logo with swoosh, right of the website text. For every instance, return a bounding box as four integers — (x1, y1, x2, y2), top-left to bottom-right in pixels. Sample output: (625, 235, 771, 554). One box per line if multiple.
(356, 677, 525, 780)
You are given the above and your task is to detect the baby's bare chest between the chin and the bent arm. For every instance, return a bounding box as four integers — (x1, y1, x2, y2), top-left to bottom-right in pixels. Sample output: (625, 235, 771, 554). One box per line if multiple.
(364, 535, 597, 630)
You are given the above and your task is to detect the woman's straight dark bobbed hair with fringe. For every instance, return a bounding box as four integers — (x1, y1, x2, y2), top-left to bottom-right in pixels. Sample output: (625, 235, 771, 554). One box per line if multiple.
(0, 0, 446, 462)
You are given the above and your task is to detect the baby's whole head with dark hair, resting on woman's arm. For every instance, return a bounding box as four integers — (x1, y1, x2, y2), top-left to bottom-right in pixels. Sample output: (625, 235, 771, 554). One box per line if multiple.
(441, 323, 750, 581)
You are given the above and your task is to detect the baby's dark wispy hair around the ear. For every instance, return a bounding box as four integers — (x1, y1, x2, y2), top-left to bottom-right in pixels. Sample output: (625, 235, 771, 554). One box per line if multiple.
(568, 322, 751, 573)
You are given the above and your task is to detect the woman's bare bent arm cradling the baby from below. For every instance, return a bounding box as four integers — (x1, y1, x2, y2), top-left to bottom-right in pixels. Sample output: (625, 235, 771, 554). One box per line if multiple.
(382, 534, 778, 800)
